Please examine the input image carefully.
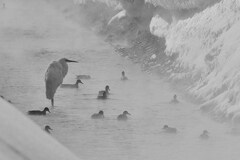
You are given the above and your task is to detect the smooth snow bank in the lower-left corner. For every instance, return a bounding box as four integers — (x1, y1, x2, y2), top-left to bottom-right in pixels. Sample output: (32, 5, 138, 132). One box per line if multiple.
(0, 98, 78, 160)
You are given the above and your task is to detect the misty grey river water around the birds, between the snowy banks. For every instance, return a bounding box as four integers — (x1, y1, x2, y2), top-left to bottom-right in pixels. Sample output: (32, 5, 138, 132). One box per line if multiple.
(0, 0, 240, 160)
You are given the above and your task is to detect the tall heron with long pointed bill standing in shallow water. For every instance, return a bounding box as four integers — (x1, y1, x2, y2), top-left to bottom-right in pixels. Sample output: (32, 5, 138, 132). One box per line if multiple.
(45, 58, 78, 106)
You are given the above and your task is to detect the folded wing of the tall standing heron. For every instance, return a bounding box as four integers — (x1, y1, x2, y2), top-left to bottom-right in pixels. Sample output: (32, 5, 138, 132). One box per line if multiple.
(45, 62, 63, 99)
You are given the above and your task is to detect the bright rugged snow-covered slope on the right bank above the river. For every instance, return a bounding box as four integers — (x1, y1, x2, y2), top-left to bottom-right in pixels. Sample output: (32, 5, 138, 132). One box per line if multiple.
(151, 0, 240, 120)
